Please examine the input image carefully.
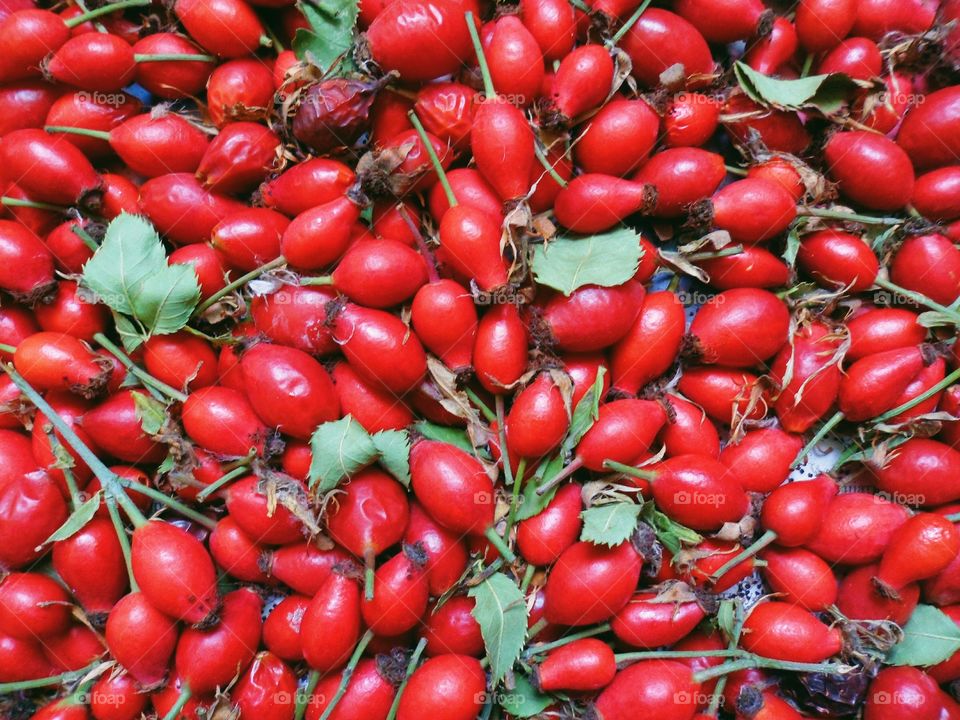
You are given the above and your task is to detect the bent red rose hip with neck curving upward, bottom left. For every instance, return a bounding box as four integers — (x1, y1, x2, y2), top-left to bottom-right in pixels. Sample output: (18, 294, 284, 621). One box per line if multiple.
(175, 588, 263, 695)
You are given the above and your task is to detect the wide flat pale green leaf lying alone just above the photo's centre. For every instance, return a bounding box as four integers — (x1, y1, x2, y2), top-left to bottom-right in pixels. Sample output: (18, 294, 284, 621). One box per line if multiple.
(533, 227, 643, 295)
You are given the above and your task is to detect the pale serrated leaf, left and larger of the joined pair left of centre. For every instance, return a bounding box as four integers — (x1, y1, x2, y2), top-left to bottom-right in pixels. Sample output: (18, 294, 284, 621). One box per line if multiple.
(309, 415, 377, 492)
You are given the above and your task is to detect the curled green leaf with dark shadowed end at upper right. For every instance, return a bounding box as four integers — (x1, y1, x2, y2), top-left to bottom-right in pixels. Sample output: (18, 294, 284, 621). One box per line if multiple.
(733, 62, 858, 115)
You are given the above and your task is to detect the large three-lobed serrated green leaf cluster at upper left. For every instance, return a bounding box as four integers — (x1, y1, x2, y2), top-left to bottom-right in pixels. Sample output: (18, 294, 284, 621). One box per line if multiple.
(83, 213, 200, 350)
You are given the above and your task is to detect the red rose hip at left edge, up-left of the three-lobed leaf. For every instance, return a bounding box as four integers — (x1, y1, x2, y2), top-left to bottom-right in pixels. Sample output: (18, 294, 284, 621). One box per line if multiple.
(0, 129, 102, 209)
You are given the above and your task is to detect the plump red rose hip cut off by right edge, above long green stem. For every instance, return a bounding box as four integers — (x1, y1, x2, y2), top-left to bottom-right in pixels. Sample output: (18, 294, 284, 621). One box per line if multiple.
(890, 233, 960, 305)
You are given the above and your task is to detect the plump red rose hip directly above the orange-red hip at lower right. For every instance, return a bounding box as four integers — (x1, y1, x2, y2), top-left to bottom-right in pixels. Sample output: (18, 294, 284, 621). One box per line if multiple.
(761, 548, 837, 612)
